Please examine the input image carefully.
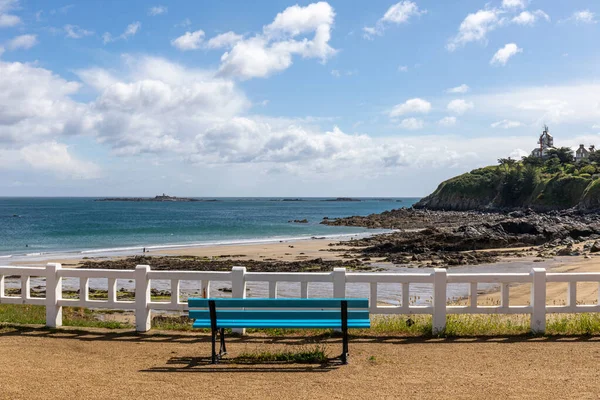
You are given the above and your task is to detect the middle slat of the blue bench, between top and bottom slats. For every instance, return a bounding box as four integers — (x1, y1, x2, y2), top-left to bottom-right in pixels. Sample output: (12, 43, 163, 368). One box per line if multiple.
(189, 309, 369, 321)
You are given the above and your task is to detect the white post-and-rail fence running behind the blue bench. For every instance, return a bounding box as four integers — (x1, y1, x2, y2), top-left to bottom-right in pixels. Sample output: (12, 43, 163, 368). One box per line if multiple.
(0, 263, 600, 333)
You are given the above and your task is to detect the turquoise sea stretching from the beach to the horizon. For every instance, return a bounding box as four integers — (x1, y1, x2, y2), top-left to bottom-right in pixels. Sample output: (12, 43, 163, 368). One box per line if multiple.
(0, 198, 418, 257)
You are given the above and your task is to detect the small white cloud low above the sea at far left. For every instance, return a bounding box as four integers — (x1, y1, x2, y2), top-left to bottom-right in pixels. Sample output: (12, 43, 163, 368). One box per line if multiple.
(19, 141, 100, 179)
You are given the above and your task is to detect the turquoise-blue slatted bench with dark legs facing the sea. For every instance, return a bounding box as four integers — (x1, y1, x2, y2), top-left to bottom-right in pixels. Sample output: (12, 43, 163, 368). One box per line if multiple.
(188, 298, 371, 364)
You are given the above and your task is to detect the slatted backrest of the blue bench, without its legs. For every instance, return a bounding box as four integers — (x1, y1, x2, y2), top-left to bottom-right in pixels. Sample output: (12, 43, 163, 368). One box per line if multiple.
(188, 298, 369, 321)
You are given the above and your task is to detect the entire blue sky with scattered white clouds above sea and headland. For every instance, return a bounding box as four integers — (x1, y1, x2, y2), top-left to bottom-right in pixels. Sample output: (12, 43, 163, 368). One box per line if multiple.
(0, 0, 600, 197)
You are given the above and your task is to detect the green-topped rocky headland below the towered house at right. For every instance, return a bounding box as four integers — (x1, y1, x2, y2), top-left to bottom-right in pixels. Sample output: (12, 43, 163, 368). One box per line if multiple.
(414, 162, 600, 212)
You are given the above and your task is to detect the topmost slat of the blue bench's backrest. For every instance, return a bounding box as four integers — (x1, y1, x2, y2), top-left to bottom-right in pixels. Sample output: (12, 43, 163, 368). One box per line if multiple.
(188, 298, 369, 310)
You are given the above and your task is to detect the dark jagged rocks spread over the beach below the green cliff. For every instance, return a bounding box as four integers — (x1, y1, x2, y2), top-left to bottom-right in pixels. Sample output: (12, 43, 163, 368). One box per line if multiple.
(327, 209, 600, 266)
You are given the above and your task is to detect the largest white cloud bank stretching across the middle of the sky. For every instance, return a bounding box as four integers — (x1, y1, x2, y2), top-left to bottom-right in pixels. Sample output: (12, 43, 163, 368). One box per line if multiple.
(67, 58, 488, 176)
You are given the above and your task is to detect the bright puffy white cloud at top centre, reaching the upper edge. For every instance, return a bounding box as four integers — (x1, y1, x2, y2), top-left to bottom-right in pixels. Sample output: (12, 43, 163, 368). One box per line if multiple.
(219, 2, 336, 79)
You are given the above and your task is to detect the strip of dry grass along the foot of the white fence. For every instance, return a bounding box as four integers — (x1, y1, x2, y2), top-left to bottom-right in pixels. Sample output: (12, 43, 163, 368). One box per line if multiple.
(0, 304, 600, 339)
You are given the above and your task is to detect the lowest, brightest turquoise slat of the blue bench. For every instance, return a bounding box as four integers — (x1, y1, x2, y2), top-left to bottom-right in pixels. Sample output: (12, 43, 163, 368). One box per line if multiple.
(193, 319, 371, 329)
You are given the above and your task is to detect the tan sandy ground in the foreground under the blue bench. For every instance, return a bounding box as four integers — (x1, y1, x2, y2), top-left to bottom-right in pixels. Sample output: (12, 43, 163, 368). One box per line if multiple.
(0, 328, 600, 400)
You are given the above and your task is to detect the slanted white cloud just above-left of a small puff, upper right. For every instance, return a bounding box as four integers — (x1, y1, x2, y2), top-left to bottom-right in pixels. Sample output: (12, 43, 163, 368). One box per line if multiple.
(446, 9, 502, 51)
